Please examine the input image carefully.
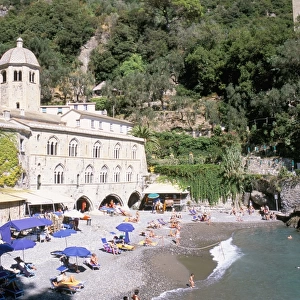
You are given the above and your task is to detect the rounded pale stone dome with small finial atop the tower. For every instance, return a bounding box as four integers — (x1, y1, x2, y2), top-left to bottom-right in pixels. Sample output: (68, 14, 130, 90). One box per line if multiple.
(0, 37, 40, 68)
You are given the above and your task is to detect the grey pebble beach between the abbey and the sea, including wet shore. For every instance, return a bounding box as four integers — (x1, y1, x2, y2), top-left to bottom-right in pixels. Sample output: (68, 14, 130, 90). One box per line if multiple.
(1, 210, 282, 300)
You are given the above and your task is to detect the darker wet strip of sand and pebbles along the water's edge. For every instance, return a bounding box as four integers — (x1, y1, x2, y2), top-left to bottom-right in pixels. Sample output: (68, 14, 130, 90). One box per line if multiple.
(114, 220, 283, 300)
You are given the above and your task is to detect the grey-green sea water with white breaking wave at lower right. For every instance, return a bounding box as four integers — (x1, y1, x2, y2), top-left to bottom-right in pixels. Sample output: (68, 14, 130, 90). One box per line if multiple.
(153, 225, 300, 300)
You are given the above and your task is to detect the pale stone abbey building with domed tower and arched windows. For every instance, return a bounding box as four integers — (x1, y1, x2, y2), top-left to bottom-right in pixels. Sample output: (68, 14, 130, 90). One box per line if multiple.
(0, 38, 147, 223)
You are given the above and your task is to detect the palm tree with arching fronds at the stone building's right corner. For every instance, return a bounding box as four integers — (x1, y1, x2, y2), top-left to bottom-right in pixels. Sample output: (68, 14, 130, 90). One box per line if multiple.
(131, 125, 160, 156)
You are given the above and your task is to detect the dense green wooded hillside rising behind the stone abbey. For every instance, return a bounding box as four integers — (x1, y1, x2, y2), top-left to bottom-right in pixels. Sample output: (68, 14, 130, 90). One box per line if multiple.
(0, 0, 300, 202)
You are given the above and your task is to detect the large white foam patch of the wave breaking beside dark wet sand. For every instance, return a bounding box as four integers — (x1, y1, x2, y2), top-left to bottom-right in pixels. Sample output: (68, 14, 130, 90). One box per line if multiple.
(206, 237, 243, 283)
